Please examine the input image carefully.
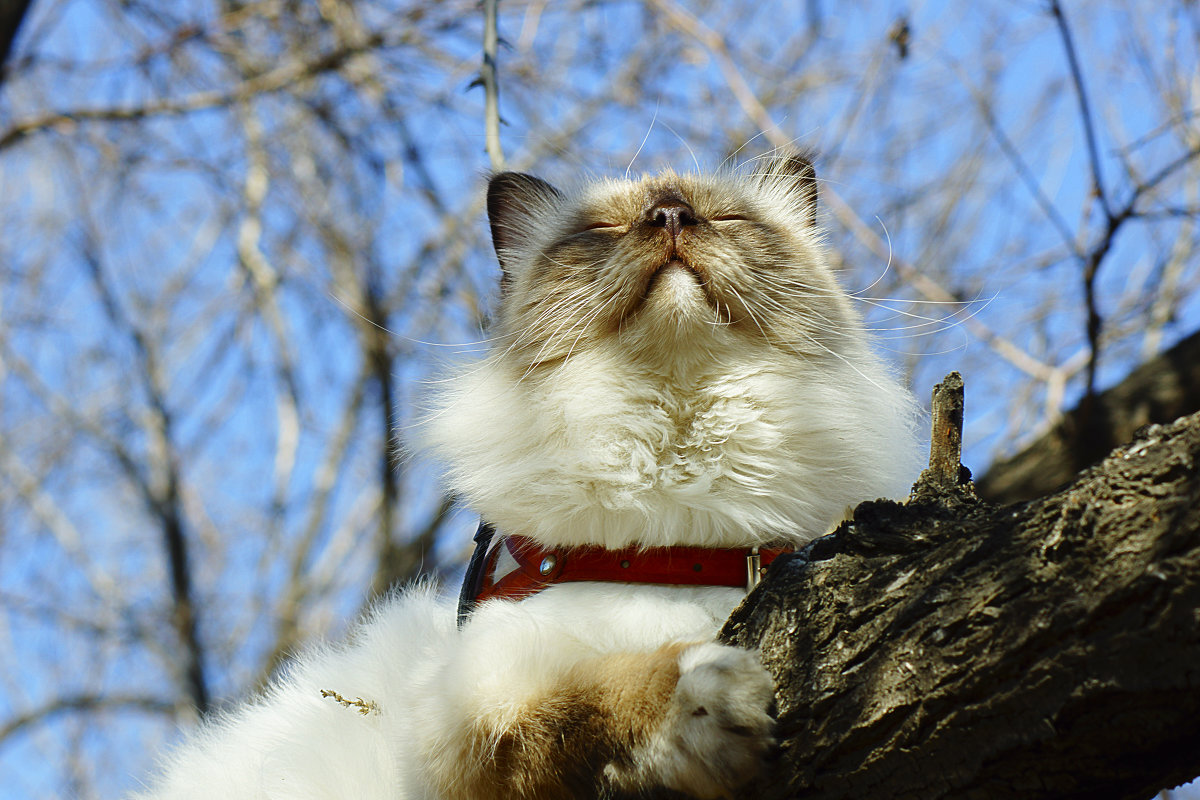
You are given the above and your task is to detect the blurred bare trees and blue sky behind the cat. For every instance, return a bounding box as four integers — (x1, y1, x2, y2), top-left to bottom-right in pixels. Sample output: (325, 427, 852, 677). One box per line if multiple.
(0, 0, 1200, 798)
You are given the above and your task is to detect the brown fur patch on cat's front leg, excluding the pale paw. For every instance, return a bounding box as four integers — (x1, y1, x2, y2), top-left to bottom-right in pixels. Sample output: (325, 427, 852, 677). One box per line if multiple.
(439, 644, 689, 800)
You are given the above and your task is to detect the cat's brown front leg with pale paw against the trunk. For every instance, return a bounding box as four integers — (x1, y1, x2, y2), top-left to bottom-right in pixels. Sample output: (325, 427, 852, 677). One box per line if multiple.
(433, 643, 774, 800)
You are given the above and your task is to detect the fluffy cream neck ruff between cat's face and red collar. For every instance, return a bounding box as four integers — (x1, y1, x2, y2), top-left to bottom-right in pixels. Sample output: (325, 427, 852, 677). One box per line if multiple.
(418, 338, 919, 547)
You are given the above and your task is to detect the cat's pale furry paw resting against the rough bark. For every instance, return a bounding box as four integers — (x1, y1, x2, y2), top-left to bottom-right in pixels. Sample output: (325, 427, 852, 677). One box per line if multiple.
(644, 643, 774, 800)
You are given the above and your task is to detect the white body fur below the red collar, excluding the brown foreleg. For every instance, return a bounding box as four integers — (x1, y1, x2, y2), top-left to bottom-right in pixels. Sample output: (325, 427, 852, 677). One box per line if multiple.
(134, 584, 748, 800)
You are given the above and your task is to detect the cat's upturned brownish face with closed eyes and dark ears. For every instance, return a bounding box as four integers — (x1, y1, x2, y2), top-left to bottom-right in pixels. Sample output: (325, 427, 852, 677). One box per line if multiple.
(488, 156, 862, 372)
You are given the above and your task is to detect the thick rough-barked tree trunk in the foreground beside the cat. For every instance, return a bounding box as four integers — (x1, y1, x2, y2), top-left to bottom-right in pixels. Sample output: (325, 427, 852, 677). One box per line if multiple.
(722, 415, 1200, 800)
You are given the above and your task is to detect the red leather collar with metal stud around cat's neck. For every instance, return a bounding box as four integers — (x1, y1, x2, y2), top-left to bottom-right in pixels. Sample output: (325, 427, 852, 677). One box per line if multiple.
(472, 536, 792, 604)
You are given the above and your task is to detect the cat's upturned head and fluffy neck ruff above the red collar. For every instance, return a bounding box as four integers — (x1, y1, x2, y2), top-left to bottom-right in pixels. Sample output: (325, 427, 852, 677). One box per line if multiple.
(422, 158, 917, 547)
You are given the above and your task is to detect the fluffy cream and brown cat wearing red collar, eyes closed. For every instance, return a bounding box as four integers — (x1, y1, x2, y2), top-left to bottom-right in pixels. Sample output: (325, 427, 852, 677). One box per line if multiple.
(138, 154, 918, 800)
